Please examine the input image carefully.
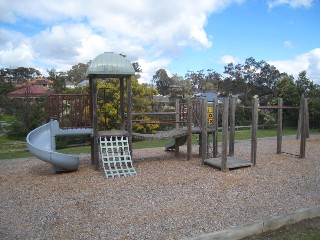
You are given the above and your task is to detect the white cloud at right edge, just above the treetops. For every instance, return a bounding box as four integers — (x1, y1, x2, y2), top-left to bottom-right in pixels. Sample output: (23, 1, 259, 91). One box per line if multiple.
(269, 48, 320, 84)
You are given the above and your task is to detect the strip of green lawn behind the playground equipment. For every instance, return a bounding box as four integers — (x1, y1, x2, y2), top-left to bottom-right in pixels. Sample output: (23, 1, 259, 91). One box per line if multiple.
(0, 129, 318, 160)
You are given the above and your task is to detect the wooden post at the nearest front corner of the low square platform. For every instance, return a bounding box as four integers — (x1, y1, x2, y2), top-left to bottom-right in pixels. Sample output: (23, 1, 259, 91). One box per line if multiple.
(221, 98, 229, 172)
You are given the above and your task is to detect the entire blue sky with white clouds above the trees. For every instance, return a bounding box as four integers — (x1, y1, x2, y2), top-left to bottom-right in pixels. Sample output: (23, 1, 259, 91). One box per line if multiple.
(0, 0, 320, 84)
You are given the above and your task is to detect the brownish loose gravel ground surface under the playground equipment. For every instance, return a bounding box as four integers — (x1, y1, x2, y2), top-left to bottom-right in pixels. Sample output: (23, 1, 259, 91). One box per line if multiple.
(0, 135, 320, 239)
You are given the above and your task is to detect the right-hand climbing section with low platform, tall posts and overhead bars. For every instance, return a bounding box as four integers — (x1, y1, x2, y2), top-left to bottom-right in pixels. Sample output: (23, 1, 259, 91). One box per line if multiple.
(202, 95, 309, 171)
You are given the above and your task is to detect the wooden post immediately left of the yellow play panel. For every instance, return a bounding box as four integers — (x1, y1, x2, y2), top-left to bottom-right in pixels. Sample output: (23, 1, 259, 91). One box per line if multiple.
(201, 98, 208, 164)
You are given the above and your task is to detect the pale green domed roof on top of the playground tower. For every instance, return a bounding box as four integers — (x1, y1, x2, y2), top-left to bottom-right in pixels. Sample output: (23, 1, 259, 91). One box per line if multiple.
(86, 52, 135, 77)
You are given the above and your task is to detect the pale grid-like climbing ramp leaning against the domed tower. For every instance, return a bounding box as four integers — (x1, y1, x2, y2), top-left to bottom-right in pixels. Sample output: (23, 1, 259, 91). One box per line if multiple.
(99, 136, 137, 178)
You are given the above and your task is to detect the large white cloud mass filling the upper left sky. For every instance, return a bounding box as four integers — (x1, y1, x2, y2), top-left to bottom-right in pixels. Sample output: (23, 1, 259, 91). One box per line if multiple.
(0, 0, 243, 81)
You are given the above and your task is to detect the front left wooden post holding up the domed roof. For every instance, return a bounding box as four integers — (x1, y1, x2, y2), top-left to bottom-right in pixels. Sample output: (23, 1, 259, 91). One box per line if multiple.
(91, 78, 99, 171)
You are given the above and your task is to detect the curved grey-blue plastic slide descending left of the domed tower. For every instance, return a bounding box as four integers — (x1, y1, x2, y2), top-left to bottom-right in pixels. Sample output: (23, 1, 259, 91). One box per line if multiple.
(26, 120, 92, 172)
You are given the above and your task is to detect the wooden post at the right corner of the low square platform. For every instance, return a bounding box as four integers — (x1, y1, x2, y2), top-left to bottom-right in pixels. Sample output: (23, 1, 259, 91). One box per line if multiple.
(251, 98, 259, 166)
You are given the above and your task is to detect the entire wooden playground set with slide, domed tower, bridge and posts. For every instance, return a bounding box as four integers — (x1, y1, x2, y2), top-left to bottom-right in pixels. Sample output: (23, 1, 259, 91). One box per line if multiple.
(27, 53, 307, 177)
